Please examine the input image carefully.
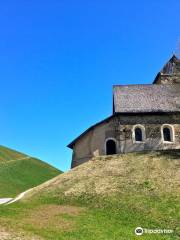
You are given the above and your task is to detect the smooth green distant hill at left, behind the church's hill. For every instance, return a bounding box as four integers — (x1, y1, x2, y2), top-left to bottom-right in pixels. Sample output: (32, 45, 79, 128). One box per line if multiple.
(0, 146, 61, 198)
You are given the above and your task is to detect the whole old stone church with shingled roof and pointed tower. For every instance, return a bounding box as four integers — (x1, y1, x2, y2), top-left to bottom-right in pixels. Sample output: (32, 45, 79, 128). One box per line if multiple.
(68, 55, 180, 167)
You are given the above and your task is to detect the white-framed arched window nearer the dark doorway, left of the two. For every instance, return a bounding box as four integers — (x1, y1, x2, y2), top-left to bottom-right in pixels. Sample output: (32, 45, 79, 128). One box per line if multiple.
(132, 124, 146, 143)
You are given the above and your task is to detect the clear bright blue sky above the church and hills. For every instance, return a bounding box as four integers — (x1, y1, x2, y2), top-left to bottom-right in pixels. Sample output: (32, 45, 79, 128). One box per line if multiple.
(0, 0, 180, 171)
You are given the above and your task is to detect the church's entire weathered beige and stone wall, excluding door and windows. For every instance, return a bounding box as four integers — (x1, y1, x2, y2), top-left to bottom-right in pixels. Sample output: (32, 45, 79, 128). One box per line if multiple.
(72, 114, 180, 167)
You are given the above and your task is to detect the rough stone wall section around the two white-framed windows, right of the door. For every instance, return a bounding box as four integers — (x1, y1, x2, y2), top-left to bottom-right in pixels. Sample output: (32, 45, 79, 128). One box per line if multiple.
(119, 114, 180, 153)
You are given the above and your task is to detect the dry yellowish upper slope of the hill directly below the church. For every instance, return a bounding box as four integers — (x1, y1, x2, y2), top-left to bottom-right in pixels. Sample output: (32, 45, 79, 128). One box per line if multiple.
(24, 150, 180, 197)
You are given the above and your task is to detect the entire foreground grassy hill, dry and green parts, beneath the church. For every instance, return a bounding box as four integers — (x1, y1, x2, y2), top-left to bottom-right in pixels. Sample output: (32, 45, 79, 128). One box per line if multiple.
(0, 151, 180, 240)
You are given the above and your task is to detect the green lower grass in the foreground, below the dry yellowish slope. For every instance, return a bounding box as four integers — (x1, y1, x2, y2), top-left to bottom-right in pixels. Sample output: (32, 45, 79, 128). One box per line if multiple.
(0, 192, 180, 240)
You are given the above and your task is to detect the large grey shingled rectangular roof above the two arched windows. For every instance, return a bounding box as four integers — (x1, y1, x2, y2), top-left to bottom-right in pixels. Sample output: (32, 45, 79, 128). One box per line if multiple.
(113, 84, 180, 113)
